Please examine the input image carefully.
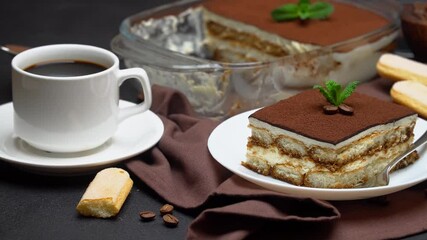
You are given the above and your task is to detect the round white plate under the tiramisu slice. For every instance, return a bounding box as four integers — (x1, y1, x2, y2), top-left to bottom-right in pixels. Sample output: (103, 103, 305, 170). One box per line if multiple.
(208, 110, 427, 200)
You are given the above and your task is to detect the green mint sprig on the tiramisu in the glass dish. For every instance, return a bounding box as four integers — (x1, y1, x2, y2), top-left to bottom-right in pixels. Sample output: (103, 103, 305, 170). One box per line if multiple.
(271, 0, 334, 22)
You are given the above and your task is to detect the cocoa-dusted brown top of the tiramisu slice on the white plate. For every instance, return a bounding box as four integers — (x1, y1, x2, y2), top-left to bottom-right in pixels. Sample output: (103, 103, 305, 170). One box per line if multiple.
(250, 89, 415, 144)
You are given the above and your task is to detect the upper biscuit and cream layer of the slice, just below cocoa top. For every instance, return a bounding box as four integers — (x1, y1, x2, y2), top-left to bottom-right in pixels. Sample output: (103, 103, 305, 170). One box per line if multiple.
(248, 115, 417, 165)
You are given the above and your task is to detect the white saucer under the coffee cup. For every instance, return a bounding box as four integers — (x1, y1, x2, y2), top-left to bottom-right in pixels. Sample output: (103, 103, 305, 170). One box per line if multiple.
(0, 100, 164, 175)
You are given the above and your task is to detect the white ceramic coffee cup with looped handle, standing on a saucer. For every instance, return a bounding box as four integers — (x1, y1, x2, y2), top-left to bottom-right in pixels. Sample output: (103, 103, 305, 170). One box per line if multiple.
(12, 44, 152, 152)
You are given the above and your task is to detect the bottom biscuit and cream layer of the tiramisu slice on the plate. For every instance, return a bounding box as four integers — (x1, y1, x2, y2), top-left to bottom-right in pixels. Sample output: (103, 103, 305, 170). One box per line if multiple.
(243, 137, 414, 188)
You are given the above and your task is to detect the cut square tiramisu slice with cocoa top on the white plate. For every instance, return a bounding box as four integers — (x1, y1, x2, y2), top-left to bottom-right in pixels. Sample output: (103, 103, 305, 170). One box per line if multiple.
(246, 90, 418, 188)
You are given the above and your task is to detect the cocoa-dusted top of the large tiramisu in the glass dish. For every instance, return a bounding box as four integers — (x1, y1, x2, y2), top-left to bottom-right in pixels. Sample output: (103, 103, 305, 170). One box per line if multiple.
(203, 0, 390, 46)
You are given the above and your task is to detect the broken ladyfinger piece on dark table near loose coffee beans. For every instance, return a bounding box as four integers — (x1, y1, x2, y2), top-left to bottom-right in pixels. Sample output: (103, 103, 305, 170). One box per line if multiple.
(76, 168, 133, 218)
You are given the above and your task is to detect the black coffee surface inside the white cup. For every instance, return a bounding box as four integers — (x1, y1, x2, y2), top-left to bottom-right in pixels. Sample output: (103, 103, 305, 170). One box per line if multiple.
(24, 60, 107, 77)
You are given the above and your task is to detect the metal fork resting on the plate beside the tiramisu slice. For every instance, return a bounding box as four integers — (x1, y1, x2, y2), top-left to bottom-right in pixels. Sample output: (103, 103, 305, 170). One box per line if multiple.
(361, 131, 427, 187)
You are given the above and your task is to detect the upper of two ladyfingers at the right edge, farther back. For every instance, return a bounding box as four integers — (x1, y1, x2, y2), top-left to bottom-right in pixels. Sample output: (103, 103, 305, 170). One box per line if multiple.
(377, 53, 427, 85)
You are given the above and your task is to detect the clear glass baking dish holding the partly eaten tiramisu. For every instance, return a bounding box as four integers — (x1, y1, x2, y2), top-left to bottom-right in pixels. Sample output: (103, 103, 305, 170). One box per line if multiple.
(111, 0, 401, 119)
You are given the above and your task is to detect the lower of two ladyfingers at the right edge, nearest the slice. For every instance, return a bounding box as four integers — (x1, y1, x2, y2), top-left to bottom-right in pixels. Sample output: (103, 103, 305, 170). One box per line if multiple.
(390, 81, 427, 118)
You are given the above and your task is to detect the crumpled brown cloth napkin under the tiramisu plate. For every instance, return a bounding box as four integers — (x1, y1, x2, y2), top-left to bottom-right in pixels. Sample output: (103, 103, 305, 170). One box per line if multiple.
(126, 81, 427, 239)
